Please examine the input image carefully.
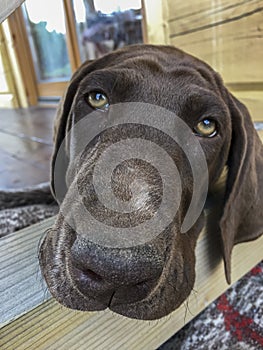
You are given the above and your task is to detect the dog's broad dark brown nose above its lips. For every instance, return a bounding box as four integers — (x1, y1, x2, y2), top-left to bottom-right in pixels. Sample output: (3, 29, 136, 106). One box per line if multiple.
(71, 239, 164, 288)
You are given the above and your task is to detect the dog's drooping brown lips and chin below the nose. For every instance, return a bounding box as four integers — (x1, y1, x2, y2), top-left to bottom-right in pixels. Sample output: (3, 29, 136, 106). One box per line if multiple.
(39, 232, 194, 320)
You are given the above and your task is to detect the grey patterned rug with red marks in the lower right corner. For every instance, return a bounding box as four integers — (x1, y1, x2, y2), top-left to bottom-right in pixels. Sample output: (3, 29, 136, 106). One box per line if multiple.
(159, 262, 263, 350)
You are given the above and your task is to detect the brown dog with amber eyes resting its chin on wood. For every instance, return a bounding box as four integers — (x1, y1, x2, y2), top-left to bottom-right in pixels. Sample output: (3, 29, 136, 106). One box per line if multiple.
(40, 45, 263, 319)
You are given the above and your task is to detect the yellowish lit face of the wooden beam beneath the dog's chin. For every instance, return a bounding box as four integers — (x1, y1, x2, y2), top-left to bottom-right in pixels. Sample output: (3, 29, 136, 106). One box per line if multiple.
(0, 221, 263, 350)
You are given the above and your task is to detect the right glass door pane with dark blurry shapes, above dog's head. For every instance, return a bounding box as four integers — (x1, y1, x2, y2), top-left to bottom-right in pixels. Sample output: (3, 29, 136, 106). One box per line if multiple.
(73, 0, 143, 61)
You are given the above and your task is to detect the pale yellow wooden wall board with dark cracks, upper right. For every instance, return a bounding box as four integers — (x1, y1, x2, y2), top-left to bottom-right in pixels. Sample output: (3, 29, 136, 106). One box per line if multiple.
(168, 0, 263, 83)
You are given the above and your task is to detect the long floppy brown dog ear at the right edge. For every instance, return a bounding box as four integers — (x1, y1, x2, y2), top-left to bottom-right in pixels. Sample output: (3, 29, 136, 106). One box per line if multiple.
(220, 93, 263, 283)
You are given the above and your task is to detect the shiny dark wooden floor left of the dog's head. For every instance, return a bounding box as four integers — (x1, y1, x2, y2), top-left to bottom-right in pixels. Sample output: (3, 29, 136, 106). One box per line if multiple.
(0, 107, 56, 189)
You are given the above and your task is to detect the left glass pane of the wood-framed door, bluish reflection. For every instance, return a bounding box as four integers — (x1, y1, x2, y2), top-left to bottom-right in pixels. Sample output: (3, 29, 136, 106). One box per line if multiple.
(22, 0, 72, 97)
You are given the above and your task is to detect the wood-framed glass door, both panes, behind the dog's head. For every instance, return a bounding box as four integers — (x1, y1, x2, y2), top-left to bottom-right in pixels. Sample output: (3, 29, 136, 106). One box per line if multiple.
(9, 0, 143, 104)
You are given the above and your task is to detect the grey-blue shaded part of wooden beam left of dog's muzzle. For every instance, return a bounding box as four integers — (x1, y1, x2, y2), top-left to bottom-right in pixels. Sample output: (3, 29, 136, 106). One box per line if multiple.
(0, 218, 54, 326)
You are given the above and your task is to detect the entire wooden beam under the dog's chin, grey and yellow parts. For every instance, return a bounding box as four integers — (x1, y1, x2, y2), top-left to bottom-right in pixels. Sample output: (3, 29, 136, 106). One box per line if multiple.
(0, 209, 263, 350)
